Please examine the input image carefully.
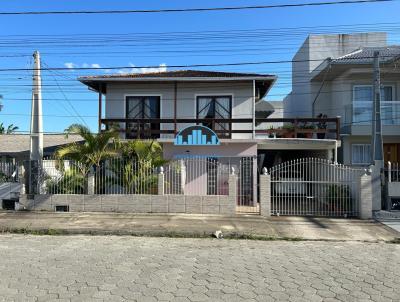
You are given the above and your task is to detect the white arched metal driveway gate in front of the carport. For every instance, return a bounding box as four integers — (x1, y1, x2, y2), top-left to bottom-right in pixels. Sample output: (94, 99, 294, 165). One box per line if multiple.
(270, 158, 363, 217)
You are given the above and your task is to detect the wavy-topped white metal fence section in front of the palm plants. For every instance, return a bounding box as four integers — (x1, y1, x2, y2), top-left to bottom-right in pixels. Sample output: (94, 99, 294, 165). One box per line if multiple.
(34, 158, 158, 194)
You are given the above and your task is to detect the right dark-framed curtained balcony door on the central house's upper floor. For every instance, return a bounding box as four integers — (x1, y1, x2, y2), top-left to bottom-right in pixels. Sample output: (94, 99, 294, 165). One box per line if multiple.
(196, 96, 232, 137)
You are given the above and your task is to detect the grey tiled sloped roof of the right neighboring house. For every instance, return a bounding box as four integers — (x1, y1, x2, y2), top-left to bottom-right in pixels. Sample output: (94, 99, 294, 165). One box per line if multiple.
(332, 45, 400, 64)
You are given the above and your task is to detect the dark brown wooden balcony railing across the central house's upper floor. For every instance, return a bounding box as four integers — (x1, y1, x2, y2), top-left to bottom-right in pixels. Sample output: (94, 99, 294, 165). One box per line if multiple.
(101, 118, 340, 140)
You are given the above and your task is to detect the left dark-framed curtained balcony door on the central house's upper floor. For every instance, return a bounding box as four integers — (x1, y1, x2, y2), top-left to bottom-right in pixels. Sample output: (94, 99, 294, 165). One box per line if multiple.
(126, 96, 160, 139)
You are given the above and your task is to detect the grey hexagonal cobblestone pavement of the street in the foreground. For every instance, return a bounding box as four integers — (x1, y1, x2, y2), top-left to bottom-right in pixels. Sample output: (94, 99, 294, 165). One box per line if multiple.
(0, 235, 400, 302)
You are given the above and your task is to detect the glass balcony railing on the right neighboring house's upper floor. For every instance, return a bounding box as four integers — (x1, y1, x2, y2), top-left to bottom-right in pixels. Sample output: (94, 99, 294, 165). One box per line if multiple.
(345, 101, 400, 126)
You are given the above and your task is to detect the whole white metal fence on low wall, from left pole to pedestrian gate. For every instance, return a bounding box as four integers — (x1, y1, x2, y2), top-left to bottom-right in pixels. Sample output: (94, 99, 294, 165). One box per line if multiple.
(25, 157, 257, 199)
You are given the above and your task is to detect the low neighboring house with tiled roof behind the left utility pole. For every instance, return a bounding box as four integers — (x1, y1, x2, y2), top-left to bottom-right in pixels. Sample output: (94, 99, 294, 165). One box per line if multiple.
(0, 134, 82, 163)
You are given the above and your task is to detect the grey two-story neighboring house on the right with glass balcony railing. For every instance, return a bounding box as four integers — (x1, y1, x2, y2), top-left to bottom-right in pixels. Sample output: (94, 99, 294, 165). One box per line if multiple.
(284, 33, 400, 165)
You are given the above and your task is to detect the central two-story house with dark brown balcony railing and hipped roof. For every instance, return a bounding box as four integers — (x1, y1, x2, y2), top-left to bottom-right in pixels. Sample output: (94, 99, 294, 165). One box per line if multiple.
(79, 70, 338, 210)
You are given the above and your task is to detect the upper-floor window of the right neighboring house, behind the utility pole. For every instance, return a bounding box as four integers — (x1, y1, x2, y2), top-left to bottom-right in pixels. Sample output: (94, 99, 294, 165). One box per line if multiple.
(353, 85, 394, 125)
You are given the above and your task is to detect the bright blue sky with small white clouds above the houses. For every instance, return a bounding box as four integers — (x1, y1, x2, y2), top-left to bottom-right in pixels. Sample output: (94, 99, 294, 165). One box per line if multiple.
(0, 0, 400, 132)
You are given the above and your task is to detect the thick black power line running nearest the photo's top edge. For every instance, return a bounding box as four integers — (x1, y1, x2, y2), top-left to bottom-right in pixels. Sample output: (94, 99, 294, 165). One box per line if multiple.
(0, 0, 397, 16)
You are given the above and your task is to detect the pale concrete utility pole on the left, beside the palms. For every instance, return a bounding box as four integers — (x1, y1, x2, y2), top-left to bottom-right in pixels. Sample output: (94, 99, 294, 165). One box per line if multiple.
(30, 51, 43, 162)
